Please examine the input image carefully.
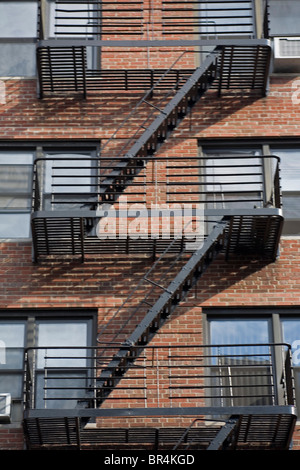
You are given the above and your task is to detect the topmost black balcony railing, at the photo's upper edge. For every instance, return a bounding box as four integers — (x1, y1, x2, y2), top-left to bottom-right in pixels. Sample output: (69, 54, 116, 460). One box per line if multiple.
(39, 0, 268, 40)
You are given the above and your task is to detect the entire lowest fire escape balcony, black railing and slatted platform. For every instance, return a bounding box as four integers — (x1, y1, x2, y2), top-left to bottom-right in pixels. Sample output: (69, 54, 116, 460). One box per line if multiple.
(24, 342, 297, 450)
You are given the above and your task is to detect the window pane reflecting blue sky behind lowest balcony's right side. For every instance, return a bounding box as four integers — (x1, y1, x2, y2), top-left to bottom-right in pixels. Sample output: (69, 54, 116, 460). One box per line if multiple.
(210, 319, 274, 406)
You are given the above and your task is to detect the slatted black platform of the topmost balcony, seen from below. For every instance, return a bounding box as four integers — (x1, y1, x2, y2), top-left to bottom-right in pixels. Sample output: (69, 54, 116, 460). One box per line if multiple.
(37, 40, 271, 98)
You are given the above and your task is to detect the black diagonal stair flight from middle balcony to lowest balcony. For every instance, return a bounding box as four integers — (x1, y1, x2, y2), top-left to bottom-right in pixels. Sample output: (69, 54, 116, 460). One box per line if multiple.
(96, 217, 229, 406)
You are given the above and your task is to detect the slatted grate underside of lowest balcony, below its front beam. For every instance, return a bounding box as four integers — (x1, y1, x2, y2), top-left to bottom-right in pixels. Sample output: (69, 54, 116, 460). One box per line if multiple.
(24, 414, 296, 450)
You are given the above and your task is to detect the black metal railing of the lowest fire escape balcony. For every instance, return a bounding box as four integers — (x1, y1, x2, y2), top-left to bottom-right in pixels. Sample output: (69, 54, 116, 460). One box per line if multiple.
(24, 344, 295, 414)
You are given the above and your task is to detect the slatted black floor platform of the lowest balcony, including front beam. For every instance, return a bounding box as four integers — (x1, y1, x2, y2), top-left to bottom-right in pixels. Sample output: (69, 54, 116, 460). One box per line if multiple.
(24, 406, 296, 451)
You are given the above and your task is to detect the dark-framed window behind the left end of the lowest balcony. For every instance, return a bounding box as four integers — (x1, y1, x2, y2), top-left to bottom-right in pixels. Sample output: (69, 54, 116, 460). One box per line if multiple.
(0, 311, 94, 420)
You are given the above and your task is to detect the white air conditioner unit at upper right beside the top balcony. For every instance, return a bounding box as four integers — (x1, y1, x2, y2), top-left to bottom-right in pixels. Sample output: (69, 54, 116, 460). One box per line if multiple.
(273, 36, 300, 73)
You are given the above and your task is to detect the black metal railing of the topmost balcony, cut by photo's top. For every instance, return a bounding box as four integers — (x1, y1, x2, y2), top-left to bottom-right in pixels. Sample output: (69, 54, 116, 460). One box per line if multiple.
(39, 0, 268, 39)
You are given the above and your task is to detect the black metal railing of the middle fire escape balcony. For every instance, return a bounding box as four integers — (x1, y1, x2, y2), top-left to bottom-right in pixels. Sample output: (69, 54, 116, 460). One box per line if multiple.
(32, 155, 281, 216)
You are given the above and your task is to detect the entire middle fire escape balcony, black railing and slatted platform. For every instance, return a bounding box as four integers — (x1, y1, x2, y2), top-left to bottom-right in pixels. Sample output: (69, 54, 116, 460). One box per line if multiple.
(31, 151, 283, 261)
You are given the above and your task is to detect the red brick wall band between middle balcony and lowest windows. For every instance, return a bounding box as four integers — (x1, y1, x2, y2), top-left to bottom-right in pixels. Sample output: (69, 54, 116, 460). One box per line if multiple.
(0, 239, 300, 312)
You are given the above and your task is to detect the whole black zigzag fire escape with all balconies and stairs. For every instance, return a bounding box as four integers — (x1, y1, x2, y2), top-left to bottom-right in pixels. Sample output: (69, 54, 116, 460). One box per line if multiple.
(24, 0, 296, 450)
